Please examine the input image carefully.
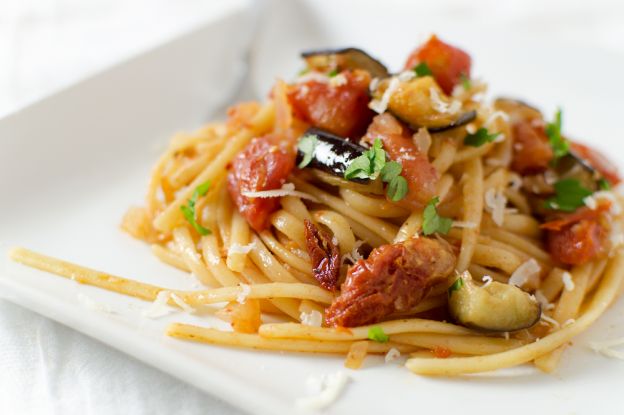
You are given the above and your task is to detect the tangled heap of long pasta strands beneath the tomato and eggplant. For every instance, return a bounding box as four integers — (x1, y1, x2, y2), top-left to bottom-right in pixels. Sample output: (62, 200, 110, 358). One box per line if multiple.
(11, 36, 624, 375)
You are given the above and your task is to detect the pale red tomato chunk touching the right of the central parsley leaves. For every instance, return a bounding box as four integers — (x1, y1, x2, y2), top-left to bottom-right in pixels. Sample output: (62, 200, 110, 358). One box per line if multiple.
(364, 112, 439, 208)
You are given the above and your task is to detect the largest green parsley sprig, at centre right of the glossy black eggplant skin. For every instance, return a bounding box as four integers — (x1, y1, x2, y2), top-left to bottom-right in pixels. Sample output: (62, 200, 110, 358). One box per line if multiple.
(344, 138, 407, 202)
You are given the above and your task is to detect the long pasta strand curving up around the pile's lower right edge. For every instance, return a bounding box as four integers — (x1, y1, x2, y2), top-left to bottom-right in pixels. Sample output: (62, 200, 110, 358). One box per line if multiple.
(405, 252, 624, 376)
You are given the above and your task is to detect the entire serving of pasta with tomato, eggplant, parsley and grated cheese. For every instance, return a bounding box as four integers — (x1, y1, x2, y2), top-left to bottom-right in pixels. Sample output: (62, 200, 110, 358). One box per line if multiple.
(11, 36, 624, 376)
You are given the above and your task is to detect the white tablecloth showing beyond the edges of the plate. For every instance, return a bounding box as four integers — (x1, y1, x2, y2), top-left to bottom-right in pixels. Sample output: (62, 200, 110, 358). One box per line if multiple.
(0, 0, 624, 414)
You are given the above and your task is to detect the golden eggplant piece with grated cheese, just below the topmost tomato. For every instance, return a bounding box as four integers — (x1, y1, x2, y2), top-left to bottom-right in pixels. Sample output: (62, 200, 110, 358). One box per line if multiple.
(373, 76, 477, 133)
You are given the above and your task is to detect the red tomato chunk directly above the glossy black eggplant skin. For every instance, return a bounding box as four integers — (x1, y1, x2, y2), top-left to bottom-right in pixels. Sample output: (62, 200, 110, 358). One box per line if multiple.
(288, 70, 374, 141)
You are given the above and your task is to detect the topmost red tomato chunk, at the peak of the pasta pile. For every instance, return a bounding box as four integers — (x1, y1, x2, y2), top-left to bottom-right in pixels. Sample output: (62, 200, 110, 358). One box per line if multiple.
(405, 35, 470, 95)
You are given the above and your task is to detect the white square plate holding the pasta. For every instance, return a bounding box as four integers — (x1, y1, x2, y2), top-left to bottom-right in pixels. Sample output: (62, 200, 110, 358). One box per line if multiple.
(0, 1, 624, 414)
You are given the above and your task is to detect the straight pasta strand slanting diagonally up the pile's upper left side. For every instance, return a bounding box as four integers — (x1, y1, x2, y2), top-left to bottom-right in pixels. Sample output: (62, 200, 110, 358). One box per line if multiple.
(154, 104, 274, 232)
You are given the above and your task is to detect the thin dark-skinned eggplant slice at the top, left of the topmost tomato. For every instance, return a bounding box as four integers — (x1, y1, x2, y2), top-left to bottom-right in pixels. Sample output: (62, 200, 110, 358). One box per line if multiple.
(301, 48, 390, 78)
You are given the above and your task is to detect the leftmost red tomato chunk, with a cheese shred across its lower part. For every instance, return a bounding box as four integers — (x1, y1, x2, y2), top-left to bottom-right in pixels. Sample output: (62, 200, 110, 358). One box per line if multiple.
(228, 134, 296, 232)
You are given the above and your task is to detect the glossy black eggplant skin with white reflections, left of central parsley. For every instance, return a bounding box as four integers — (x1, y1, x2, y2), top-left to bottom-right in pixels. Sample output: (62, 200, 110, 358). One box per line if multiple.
(297, 127, 369, 183)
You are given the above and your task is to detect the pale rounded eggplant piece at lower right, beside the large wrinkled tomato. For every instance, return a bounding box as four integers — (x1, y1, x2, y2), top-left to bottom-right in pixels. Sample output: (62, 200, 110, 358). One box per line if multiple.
(448, 273, 542, 331)
